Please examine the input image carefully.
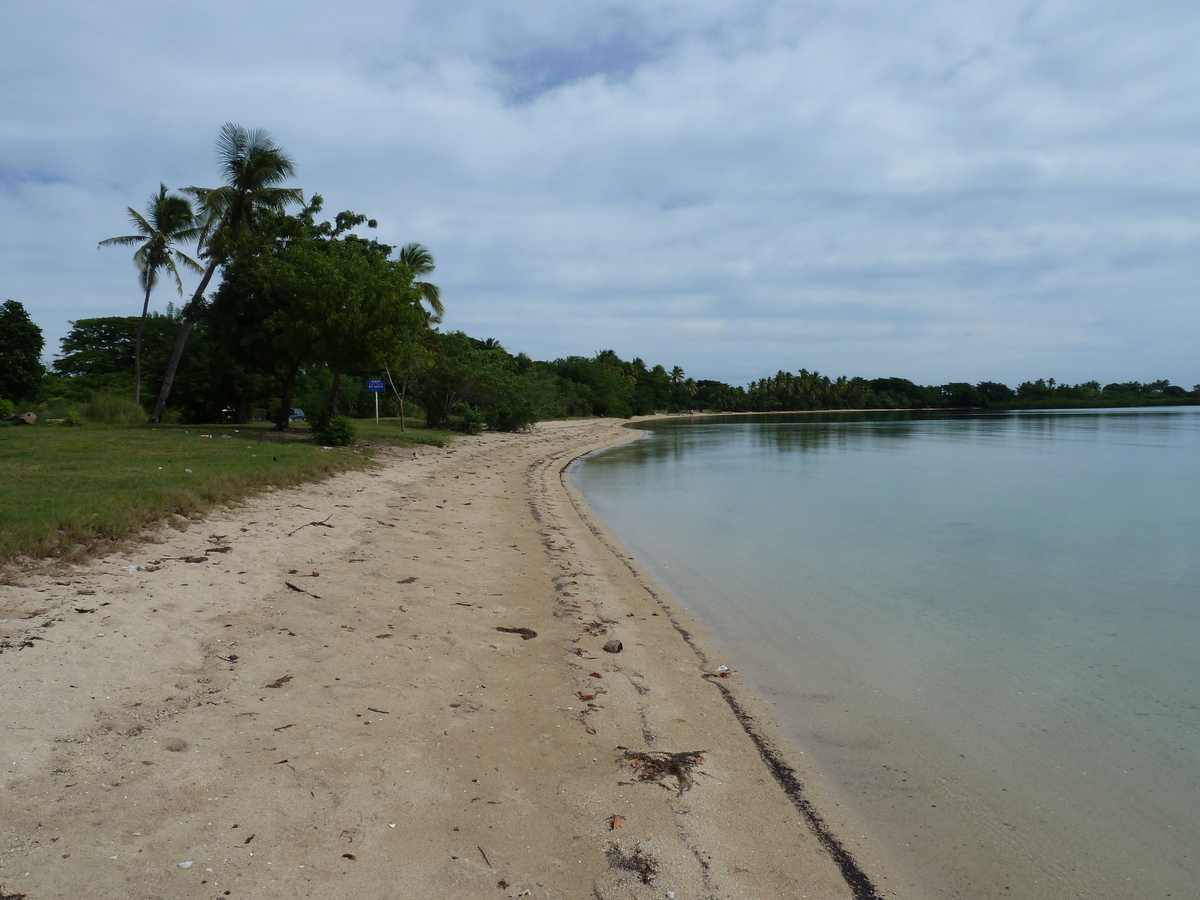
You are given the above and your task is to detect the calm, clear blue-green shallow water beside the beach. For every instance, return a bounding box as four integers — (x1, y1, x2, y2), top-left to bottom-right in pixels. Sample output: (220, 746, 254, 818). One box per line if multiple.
(572, 408, 1200, 900)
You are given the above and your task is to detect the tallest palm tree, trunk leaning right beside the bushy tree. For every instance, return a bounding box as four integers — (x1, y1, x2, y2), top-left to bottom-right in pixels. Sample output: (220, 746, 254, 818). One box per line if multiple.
(150, 122, 304, 421)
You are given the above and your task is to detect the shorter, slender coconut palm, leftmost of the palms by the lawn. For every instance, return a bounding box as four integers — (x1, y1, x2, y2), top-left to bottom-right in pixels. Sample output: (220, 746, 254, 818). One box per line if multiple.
(100, 184, 204, 403)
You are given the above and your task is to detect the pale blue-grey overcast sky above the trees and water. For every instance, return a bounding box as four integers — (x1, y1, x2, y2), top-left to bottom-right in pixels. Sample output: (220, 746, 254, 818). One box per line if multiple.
(0, 0, 1200, 388)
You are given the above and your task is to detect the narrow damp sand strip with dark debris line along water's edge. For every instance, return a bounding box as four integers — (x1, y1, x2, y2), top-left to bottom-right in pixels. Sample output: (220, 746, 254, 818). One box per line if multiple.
(559, 428, 882, 900)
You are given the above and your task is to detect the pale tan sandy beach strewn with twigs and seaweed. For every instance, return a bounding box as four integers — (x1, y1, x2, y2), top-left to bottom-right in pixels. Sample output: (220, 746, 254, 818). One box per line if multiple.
(0, 420, 875, 900)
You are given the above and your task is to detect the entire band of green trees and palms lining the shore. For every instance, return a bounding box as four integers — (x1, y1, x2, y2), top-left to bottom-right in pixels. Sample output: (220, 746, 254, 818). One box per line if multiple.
(0, 125, 1200, 429)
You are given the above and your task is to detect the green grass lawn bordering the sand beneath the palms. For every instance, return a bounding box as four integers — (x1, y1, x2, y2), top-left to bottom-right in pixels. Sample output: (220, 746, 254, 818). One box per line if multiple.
(0, 419, 449, 563)
